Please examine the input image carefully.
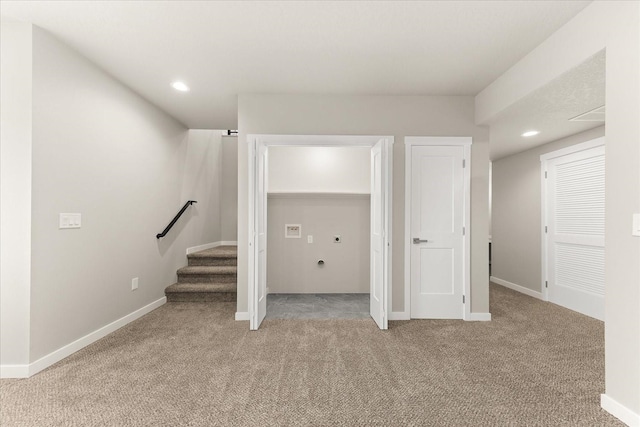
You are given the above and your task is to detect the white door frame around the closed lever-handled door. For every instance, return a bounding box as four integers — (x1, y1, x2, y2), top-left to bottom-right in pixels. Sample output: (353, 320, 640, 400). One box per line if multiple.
(403, 136, 472, 320)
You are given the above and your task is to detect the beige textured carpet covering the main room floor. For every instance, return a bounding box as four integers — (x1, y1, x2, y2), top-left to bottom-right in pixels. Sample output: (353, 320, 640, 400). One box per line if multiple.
(0, 285, 622, 426)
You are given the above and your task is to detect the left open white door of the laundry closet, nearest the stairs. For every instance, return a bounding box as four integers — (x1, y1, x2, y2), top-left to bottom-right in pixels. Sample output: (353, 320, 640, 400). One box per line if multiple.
(251, 144, 269, 329)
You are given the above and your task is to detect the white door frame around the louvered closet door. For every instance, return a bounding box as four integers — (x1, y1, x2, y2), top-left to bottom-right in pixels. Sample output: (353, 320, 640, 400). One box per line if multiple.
(540, 136, 606, 301)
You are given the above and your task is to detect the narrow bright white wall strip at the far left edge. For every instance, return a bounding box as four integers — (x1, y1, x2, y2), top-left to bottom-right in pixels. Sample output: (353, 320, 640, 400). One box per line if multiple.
(0, 22, 32, 372)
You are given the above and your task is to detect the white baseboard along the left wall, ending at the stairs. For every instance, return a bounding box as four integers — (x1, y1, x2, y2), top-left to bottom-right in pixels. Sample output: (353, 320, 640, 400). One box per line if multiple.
(1, 297, 167, 378)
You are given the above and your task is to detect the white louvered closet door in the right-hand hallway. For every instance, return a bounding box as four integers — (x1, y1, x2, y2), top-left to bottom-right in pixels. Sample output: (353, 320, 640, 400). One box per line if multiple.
(546, 146, 605, 320)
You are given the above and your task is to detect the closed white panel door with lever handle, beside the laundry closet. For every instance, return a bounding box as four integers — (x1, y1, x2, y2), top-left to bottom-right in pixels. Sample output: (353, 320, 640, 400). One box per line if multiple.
(409, 145, 465, 319)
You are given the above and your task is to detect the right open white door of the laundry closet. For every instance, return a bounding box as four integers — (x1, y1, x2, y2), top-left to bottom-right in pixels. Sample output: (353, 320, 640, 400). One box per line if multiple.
(369, 140, 388, 329)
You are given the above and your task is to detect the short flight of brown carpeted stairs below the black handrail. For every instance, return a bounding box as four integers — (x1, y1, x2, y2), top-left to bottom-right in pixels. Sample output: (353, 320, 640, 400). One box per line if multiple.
(164, 246, 238, 302)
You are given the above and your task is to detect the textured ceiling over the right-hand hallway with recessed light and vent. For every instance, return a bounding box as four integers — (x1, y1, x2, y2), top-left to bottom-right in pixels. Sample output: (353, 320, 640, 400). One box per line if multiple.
(490, 51, 606, 160)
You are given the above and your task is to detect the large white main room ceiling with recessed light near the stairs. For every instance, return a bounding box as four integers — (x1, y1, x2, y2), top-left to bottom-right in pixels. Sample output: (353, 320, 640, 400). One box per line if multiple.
(0, 0, 589, 129)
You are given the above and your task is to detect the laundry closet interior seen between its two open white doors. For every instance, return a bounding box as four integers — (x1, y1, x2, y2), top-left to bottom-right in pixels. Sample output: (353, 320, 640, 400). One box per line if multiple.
(266, 146, 371, 319)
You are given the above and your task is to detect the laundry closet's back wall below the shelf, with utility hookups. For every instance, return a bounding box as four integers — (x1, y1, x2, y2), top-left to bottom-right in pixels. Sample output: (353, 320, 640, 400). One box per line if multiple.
(267, 195, 371, 293)
